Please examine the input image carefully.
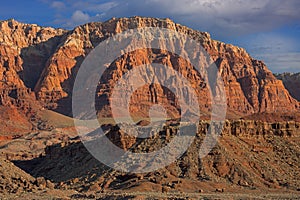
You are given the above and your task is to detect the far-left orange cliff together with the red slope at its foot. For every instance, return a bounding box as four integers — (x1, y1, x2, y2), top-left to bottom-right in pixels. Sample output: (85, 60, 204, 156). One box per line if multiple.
(0, 19, 65, 135)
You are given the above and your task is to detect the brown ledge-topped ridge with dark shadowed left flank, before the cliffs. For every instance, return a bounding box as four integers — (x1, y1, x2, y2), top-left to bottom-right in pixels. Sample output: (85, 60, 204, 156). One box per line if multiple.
(16, 120, 300, 192)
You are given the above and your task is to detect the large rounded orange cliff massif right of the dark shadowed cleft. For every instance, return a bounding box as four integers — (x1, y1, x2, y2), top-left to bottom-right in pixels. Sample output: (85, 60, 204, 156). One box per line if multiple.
(31, 17, 298, 115)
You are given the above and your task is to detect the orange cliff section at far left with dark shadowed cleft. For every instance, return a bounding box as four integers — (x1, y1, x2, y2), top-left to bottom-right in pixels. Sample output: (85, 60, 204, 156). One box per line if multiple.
(0, 19, 65, 108)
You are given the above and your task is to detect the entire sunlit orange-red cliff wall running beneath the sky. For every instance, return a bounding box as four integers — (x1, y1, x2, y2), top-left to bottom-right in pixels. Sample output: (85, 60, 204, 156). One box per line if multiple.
(0, 17, 299, 116)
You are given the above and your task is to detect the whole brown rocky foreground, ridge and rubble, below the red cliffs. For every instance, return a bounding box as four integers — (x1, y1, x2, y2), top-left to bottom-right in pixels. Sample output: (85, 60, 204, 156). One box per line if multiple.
(0, 120, 300, 199)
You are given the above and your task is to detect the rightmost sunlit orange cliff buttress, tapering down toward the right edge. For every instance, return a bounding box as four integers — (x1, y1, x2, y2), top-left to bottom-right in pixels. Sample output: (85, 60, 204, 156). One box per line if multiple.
(205, 41, 298, 113)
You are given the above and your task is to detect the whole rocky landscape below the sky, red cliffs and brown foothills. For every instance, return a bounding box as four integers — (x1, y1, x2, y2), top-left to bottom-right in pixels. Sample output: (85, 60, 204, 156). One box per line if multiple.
(0, 17, 300, 198)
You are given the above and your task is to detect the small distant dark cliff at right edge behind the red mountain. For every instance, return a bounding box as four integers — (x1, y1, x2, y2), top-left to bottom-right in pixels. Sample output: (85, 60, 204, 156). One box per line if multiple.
(275, 73, 300, 101)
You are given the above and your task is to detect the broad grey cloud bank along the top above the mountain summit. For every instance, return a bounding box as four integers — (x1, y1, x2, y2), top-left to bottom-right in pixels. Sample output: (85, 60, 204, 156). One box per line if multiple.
(47, 0, 300, 38)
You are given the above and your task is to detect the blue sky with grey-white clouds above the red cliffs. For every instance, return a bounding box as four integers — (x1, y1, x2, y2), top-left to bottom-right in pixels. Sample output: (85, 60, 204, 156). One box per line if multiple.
(0, 0, 300, 72)
